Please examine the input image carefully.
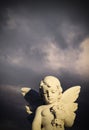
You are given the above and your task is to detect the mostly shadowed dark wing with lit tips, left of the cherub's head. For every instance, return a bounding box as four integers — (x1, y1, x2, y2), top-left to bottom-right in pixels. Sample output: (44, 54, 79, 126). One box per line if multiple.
(21, 87, 43, 114)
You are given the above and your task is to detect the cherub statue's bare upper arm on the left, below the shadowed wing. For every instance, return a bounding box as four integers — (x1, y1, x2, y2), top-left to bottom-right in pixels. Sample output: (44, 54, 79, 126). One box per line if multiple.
(32, 107, 41, 130)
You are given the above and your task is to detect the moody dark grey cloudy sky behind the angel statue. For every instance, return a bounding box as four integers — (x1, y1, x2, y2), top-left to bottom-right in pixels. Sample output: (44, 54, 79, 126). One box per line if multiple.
(0, 0, 89, 130)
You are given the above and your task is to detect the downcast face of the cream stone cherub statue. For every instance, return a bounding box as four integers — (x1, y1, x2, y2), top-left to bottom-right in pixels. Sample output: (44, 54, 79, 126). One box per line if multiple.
(43, 85, 59, 104)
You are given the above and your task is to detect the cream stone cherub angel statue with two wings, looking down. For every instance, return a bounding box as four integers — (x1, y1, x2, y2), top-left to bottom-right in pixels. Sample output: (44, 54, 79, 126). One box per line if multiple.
(21, 76, 80, 130)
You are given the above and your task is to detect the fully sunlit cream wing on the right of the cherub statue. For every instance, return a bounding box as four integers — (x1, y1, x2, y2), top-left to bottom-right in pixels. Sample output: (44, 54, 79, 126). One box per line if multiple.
(60, 86, 81, 127)
